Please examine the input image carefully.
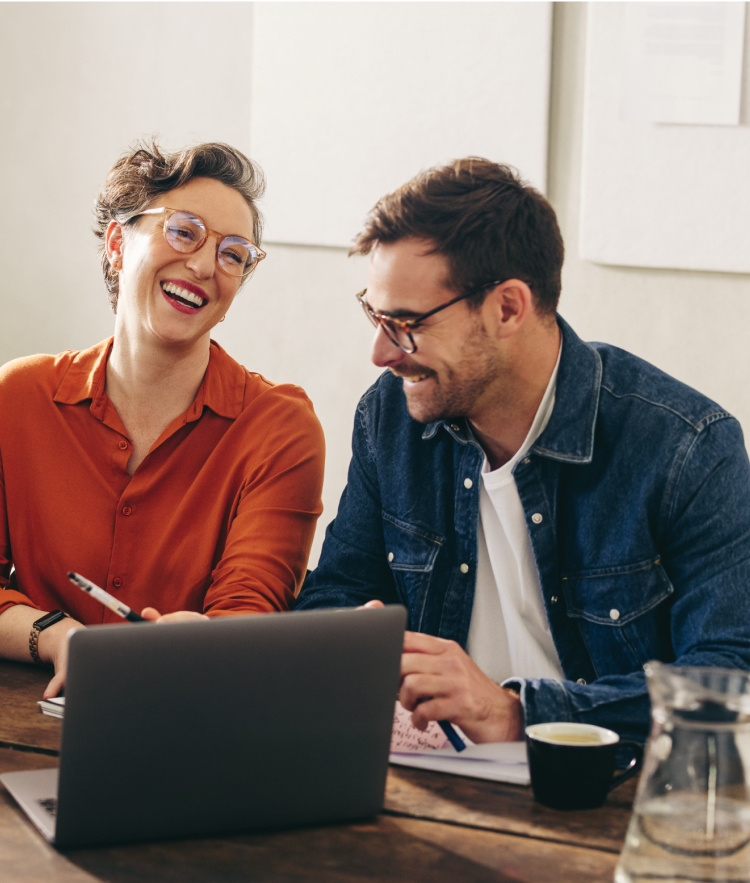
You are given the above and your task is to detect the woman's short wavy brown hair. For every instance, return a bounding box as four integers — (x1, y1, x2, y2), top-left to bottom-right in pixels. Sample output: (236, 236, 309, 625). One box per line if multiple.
(94, 140, 265, 312)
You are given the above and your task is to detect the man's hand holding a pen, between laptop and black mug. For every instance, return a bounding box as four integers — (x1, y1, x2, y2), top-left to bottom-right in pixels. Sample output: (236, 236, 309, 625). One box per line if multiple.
(399, 632, 523, 742)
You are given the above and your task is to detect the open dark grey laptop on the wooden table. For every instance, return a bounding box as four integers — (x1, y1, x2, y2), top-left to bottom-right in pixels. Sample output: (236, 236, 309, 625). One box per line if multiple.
(0, 605, 406, 849)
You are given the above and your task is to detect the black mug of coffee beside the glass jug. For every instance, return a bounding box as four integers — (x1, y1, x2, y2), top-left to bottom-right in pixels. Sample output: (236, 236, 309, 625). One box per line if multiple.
(526, 721, 643, 809)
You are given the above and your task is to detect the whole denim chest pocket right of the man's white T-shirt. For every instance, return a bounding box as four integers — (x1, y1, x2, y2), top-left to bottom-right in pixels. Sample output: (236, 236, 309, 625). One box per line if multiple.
(562, 557, 674, 677)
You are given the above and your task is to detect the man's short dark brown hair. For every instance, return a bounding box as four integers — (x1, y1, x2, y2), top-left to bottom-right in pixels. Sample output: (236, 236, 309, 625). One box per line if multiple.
(349, 156, 565, 314)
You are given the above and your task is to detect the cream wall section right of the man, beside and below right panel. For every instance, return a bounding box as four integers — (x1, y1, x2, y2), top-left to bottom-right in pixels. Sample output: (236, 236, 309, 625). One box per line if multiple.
(548, 3, 750, 437)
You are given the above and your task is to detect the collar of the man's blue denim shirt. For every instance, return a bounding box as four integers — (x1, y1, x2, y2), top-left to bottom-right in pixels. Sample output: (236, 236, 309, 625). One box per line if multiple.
(422, 316, 602, 463)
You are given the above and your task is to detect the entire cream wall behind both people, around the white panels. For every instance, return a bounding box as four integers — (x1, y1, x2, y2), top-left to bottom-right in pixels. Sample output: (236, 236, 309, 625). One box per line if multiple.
(0, 2, 750, 561)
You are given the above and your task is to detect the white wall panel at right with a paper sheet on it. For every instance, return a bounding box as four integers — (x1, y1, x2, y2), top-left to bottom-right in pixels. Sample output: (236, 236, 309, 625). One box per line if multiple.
(580, 3, 750, 273)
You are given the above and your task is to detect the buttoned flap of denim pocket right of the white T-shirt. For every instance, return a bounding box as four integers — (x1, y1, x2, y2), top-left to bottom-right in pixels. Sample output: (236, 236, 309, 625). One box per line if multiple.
(562, 558, 674, 626)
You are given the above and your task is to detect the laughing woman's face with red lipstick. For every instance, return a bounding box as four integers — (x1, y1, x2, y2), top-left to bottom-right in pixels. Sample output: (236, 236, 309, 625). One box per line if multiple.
(107, 178, 254, 346)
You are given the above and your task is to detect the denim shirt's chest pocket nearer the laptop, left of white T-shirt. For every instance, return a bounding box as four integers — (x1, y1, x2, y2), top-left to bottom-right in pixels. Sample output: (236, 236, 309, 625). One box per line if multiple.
(383, 512, 444, 629)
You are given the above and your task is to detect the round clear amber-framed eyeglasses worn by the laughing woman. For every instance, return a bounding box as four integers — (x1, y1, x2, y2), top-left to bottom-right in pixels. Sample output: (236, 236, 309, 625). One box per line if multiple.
(130, 207, 266, 277)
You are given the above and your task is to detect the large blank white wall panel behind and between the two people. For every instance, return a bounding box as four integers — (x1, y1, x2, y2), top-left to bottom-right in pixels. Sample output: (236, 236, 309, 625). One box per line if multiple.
(251, 2, 552, 246)
